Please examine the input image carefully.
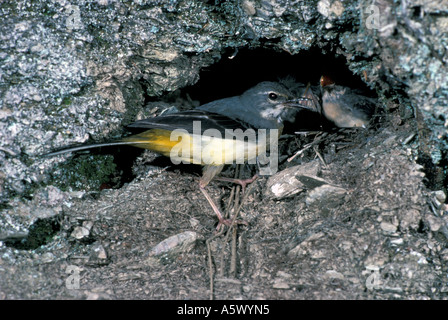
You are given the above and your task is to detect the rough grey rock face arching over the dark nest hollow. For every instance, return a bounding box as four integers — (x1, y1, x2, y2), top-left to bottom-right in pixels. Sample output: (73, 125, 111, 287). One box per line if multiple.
(0, 0, 448, 208)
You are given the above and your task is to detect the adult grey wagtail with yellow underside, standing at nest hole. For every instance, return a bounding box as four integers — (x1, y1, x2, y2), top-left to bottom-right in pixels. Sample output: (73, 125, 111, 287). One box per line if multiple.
(46, 82, 315, 228)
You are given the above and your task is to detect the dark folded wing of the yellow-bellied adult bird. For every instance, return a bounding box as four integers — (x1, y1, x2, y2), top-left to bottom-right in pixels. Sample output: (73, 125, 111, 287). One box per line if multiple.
(129, 110, 250, 134)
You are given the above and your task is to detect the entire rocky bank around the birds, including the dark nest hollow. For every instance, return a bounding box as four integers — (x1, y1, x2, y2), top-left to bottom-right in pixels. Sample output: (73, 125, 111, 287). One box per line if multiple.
(0, 0, 448, 299)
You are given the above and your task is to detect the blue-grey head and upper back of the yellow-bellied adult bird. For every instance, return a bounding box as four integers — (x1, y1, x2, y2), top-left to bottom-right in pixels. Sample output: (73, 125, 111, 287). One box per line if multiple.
(198, 81, 314, 129)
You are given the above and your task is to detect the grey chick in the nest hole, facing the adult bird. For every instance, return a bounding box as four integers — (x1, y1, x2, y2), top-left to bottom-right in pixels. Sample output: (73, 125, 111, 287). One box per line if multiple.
(320, 76, 377, 128)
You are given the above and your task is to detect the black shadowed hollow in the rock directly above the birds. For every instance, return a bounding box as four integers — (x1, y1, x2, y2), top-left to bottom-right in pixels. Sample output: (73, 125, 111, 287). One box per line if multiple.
(183, 48, 368, 104)
